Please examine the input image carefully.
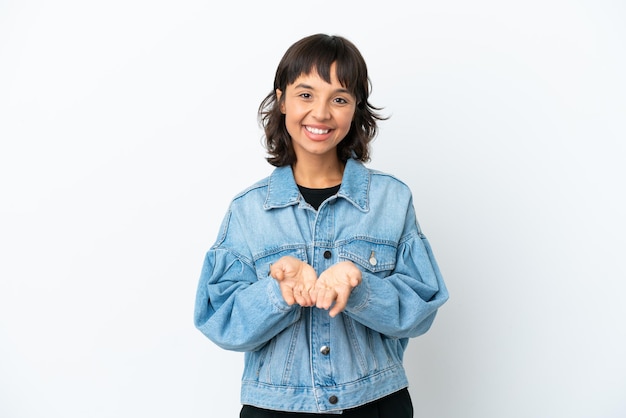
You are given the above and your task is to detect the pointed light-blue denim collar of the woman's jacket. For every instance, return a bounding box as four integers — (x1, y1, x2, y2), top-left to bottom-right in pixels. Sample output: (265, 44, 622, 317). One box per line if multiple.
(263, 158, 370, 212)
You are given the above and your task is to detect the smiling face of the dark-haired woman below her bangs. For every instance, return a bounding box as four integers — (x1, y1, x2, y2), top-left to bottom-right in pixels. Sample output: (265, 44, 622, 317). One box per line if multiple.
(276, 64, 356, 162)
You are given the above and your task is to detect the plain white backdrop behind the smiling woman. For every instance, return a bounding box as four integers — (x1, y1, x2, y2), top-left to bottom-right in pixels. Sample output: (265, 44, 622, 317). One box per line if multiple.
(0, 0, 626, 418)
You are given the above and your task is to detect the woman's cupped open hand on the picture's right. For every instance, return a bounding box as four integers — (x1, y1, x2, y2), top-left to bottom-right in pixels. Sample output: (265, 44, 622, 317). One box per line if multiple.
(311, 261, 362, 317)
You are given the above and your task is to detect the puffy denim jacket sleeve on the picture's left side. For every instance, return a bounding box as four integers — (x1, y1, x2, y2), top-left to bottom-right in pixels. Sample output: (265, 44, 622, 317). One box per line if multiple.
(194, 211, 301, 351)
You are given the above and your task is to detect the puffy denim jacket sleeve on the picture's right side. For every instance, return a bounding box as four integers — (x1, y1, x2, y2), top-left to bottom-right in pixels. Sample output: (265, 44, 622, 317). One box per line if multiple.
(344, 200, 449, 338)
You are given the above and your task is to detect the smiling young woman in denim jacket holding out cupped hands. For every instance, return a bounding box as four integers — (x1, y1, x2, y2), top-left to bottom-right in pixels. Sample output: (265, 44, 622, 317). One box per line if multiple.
(195, 34, 448, 418)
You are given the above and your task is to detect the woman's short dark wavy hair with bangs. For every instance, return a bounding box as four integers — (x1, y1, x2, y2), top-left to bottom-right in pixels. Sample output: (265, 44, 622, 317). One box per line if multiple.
(258, 34, 387, 167)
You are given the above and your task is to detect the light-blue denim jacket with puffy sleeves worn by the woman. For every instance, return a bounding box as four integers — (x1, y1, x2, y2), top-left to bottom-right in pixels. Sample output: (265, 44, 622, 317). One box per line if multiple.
(194, 160, 448, 413)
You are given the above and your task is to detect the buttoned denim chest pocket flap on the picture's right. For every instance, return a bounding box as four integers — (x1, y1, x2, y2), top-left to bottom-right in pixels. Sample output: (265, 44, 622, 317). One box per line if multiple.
(339, 239, 396, 277)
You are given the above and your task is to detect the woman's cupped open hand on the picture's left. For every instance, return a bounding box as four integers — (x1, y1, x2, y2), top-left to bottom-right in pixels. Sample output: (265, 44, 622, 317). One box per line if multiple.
(270, 256, 317, 306)
